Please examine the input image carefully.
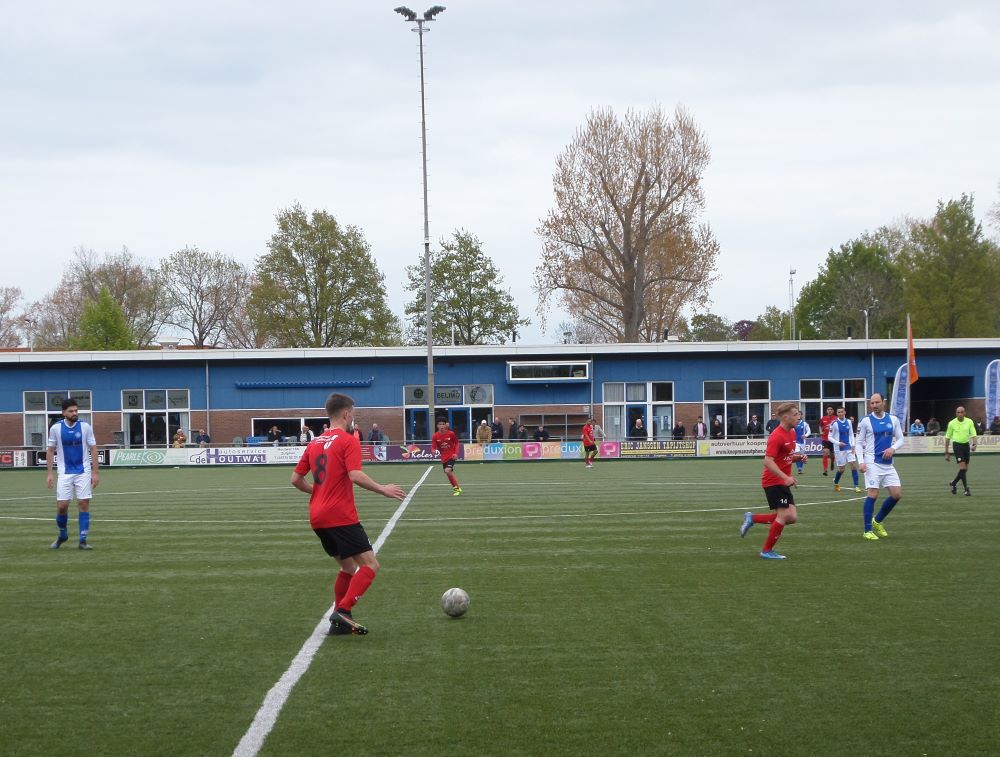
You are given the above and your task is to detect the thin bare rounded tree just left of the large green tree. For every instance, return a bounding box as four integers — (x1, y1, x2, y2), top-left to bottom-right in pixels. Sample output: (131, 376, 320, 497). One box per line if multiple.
(159, 247, 247, 347)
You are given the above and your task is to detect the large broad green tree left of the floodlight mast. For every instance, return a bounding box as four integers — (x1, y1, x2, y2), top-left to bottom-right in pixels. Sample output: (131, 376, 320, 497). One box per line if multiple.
(250, 204, 400, 347)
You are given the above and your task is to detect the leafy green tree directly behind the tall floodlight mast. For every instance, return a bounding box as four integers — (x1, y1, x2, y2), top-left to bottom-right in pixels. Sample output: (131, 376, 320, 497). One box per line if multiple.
(406, 229, 529, 344)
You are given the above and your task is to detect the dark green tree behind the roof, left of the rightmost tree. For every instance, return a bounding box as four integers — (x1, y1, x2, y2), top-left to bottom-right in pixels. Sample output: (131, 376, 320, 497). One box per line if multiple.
(795, 227, 906, 339)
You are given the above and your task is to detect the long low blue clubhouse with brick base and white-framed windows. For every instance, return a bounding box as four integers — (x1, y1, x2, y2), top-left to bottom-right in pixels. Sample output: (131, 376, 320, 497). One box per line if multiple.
(0, 339, 1000, 449)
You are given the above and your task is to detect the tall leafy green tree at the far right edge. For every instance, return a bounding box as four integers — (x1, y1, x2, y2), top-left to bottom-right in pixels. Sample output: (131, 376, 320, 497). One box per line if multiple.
(901, 195, 1000, 338)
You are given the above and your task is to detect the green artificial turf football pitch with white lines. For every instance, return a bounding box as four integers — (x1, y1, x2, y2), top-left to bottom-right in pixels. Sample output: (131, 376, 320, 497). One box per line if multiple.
(0, 455, 1000, 756)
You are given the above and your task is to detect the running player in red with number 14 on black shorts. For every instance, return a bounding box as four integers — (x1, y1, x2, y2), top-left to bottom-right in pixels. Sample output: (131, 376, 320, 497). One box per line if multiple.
(740, 402, 801, 560)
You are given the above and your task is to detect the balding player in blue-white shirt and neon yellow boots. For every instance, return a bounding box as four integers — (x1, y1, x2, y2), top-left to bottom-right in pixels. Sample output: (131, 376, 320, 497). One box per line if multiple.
(856, 392, 904, 541)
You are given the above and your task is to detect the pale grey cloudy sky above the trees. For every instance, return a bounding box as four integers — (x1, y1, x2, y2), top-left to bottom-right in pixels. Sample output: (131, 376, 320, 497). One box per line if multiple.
(0, 0, 1000, 342)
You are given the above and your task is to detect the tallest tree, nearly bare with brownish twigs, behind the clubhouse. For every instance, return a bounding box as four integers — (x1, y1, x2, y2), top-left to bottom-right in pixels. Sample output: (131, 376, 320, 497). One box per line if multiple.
(535, 108, 719, 342)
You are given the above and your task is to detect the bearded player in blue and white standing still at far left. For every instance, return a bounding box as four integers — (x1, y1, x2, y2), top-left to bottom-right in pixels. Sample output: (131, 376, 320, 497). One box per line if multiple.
(45, 398, 101, 549)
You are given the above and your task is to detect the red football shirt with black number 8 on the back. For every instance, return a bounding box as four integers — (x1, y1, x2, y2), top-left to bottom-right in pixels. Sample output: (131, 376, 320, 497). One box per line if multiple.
(295, 428, 361, 528)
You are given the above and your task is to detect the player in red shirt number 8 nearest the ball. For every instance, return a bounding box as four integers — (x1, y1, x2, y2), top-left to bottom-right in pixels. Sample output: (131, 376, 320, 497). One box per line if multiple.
(292, 394, 406, 636)
